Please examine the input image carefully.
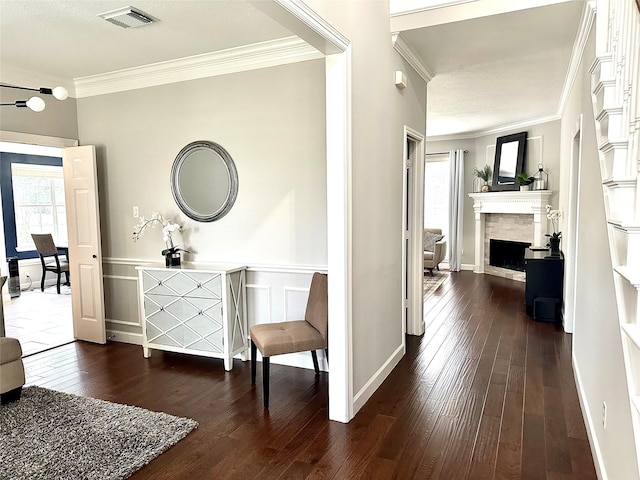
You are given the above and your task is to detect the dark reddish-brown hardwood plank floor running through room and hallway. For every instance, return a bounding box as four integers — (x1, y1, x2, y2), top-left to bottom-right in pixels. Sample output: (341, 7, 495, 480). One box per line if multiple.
(25, 272, 596, 480)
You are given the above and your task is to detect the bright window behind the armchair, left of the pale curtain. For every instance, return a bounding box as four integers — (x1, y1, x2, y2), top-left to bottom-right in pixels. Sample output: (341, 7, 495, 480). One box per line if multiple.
(424, 155, 450, 235)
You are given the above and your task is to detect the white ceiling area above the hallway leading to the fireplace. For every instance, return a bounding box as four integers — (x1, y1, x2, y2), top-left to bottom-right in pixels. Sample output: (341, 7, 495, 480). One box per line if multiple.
(401, 2, 584, 137)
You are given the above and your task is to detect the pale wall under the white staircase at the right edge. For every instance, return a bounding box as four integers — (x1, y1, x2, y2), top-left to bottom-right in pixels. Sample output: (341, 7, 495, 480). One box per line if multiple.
(559, 21, 638, 479)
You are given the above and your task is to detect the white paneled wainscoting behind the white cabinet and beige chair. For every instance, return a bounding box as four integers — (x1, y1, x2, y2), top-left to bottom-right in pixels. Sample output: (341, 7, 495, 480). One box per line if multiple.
(103, 258, 328, 371)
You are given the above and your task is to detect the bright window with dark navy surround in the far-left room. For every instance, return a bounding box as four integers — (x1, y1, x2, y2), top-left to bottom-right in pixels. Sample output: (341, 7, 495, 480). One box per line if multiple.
(0, 152, 68, 259)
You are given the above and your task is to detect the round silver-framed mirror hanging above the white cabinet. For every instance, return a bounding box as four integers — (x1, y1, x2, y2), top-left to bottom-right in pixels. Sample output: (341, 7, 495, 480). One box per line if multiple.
(171, 140, 238, 222)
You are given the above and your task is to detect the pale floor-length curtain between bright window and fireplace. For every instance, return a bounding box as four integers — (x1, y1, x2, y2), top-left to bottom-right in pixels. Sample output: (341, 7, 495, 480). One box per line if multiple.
(447, 150, 464, 272)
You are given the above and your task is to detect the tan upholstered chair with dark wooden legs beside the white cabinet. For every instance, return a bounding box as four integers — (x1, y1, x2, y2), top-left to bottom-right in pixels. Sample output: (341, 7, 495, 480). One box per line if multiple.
(249, 272, 328, 409)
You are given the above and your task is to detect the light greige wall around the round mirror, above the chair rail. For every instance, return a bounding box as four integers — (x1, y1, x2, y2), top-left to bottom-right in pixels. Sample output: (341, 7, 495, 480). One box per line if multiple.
(78, 60, 326, 265)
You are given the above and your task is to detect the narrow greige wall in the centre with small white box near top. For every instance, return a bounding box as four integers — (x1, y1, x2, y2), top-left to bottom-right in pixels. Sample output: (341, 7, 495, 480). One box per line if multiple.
(296, 0, 426, 411)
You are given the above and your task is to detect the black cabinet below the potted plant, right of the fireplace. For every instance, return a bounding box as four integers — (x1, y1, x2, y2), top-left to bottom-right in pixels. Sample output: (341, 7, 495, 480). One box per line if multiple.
(524, 249, 564, 321)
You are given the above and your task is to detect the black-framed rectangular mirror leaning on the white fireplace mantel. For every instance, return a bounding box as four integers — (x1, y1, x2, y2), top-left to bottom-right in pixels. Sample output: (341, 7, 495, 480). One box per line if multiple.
(491, 132, 527, 192)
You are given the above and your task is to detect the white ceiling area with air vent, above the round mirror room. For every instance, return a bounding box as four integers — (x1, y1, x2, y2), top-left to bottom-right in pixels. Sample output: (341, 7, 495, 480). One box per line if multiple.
(0, 0, 292, 80)
